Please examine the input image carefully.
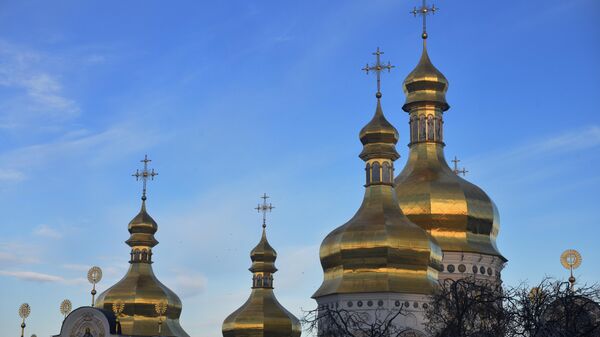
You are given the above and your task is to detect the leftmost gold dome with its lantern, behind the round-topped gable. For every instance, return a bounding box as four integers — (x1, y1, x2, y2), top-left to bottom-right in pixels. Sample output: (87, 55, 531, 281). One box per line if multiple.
(95, 198, 189, 337)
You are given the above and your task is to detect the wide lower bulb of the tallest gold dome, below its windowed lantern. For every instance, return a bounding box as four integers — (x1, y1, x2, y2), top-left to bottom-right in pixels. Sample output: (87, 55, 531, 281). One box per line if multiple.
(395, 143, 506, 261)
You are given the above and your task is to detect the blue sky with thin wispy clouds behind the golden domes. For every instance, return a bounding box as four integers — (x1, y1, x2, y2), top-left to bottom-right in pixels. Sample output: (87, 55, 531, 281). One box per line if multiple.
(0, 0, 600, 337)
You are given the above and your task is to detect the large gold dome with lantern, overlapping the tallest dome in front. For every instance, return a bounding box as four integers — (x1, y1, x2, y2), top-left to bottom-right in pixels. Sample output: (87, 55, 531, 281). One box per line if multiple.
(313, 97, 442, 298)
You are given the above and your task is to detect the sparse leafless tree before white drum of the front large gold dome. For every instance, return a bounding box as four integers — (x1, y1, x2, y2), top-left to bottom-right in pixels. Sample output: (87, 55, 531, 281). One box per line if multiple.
(302, 306, 419, 337)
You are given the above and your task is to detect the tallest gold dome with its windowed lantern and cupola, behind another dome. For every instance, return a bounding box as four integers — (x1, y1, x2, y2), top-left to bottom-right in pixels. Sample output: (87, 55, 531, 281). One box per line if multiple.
(394, 43, 506, 261)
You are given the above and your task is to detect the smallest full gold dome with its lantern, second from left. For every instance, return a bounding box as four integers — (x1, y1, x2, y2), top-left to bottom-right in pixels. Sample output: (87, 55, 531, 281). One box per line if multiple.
(222, 227, 302, 337)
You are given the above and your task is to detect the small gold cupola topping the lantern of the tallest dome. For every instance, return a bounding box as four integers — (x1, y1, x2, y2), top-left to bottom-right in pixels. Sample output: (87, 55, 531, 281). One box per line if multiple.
(402, 41, 450, 112)
